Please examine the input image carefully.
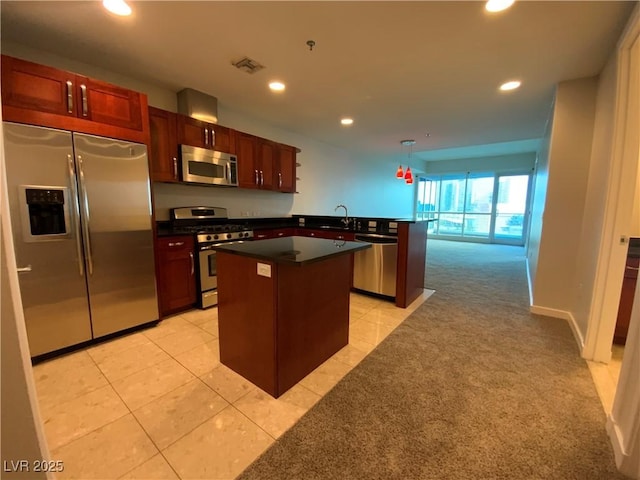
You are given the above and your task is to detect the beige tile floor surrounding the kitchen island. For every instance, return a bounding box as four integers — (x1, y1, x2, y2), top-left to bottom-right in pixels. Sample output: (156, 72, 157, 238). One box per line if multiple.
(33, 290, 433, 480)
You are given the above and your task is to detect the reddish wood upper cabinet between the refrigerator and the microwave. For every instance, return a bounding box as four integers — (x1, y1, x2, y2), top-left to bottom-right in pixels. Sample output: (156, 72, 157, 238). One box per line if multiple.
(149, 107, 180, 182)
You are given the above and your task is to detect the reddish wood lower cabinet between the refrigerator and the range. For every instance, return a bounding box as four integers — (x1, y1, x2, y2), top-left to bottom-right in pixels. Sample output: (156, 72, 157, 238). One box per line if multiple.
(156, 236, 196, 316)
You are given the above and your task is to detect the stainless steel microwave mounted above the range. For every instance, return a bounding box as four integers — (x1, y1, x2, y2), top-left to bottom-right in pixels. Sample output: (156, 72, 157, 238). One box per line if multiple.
(181, 145, 238, 187)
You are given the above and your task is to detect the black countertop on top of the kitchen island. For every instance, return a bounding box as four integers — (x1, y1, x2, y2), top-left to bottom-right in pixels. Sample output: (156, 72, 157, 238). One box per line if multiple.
(214, 237, 371, 266)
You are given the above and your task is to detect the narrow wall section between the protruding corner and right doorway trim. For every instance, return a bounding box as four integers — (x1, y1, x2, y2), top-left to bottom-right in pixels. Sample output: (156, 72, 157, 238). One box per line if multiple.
(571, 51, 617, 337)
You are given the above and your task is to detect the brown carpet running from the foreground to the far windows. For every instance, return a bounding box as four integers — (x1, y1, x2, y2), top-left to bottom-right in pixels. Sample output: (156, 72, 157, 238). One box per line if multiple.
(238, 240, 625, 480)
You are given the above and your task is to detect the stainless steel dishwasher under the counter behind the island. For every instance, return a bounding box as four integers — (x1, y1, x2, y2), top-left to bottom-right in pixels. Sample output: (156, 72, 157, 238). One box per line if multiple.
(353, 233, 398, 297)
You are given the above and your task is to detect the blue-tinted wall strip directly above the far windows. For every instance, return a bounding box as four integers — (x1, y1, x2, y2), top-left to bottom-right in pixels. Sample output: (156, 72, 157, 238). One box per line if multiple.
(425, 152, 536, 174)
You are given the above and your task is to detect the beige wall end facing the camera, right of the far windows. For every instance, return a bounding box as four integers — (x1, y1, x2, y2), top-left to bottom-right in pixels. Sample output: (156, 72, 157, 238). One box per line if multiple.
(529, 77, 597, 318)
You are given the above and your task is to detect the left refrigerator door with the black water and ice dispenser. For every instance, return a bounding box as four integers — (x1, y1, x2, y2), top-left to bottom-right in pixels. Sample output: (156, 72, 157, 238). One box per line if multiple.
(3, 122, 91, 357)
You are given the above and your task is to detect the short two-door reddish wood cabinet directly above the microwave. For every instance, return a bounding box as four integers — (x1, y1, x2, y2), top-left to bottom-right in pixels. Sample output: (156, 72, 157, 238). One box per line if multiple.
(178, 115, 236, 153)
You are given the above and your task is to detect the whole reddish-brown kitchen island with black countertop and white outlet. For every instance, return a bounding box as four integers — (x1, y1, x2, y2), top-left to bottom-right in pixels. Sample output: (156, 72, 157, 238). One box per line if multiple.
(215, 236, 370, 398)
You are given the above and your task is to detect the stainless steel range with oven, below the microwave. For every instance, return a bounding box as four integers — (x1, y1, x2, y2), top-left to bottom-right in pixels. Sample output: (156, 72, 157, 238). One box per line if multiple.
(170, 207, 253, 308)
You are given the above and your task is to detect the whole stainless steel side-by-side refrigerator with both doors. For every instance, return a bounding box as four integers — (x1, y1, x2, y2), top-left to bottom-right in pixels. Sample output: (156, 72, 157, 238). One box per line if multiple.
(3, 122, 158, 357)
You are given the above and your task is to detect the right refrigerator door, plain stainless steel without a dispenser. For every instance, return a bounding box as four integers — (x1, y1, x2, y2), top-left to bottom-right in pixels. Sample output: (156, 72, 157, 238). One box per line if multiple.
(73, 133, 158, 338)
